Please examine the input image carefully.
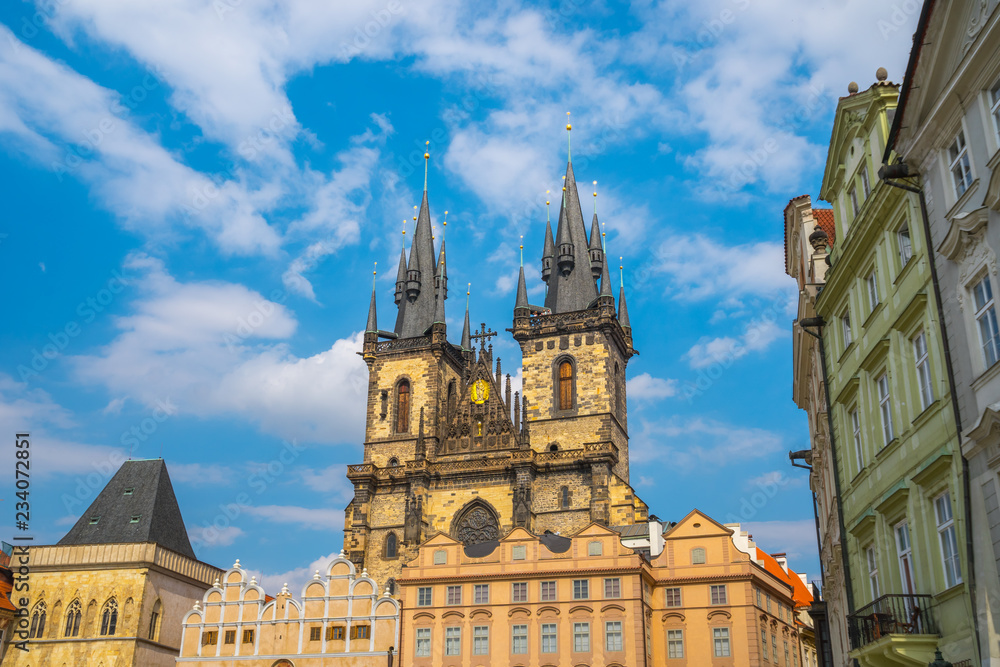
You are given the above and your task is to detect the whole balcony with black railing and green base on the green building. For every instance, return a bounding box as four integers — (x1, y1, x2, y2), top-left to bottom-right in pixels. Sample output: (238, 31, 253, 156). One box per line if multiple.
(847, 595, 940, 665)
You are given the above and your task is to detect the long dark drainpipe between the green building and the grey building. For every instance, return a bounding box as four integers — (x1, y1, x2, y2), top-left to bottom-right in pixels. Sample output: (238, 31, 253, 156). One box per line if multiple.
(878, 160, 982, 655)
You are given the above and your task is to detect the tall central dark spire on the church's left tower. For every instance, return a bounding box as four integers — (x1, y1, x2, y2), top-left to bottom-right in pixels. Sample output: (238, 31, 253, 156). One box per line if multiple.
(396, 190, 447, 338)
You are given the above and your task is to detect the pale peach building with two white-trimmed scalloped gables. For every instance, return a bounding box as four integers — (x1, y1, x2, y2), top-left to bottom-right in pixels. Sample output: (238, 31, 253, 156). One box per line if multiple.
(176, 553, 400, 667)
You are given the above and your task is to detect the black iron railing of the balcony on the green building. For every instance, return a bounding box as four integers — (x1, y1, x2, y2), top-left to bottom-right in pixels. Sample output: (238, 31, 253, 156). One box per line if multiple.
(847, 595, 939, 649)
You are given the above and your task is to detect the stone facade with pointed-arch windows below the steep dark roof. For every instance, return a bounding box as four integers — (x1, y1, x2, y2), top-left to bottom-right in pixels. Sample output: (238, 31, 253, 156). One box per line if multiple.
(3, 542, 222, 667)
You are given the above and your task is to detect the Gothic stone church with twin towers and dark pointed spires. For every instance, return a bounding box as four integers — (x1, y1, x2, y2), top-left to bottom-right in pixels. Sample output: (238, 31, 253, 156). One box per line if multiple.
(344, 147, 647, 589)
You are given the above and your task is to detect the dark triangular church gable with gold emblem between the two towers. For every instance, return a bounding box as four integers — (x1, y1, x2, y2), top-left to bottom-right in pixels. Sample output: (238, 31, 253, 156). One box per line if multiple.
(437, 355, 519, 455)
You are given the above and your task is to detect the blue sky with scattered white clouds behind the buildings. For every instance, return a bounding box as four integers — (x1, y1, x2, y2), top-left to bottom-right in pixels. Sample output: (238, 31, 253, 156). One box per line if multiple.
(0, 0, 919, 586)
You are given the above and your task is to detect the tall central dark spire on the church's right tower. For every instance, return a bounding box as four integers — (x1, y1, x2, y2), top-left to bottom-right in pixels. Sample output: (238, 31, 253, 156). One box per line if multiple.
(545, 162, 597, 313)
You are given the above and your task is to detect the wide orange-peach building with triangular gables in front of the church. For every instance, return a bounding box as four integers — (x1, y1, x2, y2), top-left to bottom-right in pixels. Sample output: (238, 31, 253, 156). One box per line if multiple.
(398, 511, 804, 667)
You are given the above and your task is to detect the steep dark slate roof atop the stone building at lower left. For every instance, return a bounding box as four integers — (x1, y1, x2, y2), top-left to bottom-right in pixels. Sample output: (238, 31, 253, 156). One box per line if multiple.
(59, 459, 195, 558)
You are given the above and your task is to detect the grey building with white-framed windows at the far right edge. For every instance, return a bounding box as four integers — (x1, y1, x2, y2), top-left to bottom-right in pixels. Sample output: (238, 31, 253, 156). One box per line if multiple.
(891, 0, 1000, 667)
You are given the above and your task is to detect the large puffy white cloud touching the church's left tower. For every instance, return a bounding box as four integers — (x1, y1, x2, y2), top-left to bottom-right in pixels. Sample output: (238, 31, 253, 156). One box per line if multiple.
(72, 255, 368, 443)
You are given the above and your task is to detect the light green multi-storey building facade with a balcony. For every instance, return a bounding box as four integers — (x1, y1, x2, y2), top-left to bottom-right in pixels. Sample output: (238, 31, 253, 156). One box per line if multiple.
(816, 69, 978, 665)
